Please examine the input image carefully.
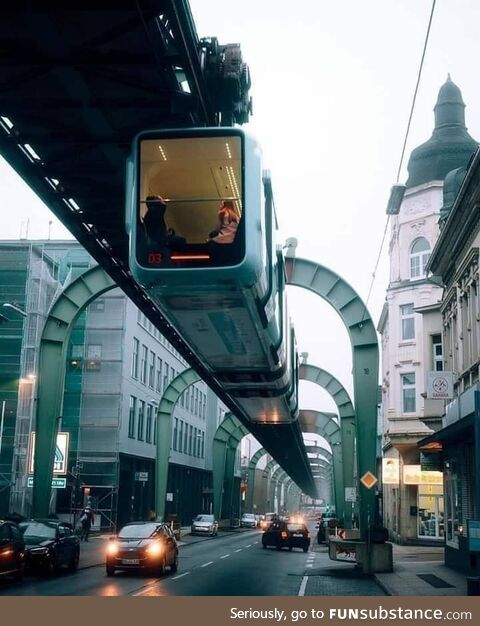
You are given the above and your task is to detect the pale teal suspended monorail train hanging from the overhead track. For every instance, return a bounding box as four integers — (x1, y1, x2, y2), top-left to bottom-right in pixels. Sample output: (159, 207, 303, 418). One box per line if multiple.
(126, 128, 298, 424)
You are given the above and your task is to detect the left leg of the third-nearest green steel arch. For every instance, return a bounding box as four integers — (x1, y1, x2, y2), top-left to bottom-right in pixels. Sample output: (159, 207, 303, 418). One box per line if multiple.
(213, 413, 248, 519)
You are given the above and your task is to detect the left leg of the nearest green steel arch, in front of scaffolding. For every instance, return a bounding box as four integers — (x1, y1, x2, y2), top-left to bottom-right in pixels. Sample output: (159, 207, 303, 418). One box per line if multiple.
(32, 265, 118, 517)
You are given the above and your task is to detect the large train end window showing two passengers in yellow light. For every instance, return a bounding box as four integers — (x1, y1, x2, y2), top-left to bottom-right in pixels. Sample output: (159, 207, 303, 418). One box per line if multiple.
(137, 135, 245, 268)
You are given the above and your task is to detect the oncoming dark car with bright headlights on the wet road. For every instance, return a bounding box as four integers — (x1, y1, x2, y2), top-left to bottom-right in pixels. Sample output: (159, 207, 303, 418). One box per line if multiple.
(106, 522, 178, 576)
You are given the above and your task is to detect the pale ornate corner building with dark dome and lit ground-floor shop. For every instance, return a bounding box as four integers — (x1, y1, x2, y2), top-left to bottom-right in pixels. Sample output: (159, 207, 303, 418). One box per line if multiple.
(378, 77, 477, 543)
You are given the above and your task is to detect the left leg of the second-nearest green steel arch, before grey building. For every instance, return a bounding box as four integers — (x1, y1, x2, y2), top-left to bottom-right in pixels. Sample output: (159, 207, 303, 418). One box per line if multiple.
(155, 367, 201, 520)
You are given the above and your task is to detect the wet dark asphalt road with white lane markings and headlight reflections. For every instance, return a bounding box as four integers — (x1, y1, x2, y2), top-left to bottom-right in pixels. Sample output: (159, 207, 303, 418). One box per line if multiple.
(0, 531, 384, 596)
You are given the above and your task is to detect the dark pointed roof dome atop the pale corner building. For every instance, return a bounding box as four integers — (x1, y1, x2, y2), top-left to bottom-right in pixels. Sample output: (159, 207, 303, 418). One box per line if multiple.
(406, 74, 478, 188)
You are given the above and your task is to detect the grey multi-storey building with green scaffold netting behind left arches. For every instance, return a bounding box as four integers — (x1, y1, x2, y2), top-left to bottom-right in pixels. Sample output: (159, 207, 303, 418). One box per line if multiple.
(0, 241, 236, 528)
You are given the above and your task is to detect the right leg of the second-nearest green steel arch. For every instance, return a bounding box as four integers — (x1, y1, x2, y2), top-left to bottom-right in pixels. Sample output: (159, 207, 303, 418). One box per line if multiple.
(300, 363, 356, 528)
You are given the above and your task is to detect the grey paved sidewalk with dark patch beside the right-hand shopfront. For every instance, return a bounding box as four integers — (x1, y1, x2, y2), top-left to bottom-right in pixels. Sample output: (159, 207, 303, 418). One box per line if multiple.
(375, 544, 467, 596)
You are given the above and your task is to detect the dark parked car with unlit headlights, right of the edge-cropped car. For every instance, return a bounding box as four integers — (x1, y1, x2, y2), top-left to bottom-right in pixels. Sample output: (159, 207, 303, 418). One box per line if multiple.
(19, 519, 80, 574)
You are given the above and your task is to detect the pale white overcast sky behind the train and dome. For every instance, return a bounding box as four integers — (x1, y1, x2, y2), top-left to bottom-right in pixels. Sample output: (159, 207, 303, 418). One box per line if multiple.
(0, 0, 480, 420)
